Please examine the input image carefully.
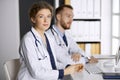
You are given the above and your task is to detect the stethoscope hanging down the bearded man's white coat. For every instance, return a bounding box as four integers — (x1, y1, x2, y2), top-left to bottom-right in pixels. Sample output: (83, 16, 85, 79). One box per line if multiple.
(51, 27, 67, 48)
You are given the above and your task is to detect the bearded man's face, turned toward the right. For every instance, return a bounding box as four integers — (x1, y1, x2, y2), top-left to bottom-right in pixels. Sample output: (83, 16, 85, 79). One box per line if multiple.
(60, 8, 73, 29)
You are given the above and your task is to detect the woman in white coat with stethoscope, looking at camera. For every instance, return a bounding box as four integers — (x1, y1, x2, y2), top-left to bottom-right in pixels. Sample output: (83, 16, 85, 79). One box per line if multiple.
(17, 1, 83, 80)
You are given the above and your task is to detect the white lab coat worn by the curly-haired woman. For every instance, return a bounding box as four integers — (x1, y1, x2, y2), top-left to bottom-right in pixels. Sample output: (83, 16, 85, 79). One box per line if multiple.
(17, 28, 62, 80)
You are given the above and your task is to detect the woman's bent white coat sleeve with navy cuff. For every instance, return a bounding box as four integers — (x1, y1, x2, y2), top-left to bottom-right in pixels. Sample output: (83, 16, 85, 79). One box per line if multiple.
(20, 37, 64, 80)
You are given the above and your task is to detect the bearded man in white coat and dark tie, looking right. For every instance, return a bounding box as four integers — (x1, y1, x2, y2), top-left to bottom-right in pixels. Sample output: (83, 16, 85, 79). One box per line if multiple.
(47, 5, 98, 68)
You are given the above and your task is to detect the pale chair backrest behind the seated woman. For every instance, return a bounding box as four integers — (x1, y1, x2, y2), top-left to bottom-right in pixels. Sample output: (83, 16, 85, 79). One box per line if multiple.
(4, 59, 20, 80)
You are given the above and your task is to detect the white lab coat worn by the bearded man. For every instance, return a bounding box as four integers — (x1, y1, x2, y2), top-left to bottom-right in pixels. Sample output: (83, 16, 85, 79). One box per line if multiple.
(47, 25, 87, 68)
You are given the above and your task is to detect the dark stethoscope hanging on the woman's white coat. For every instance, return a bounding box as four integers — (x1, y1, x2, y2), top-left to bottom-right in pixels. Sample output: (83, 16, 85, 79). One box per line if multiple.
(30, 30, 47, 60)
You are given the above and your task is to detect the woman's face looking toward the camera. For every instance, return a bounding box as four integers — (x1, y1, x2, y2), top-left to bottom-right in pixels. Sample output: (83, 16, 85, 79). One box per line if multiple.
(32, 9, 52, 31)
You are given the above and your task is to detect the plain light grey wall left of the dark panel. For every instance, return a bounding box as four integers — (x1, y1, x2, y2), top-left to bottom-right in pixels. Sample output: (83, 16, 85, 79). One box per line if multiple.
(0, 0, 19, 80)
